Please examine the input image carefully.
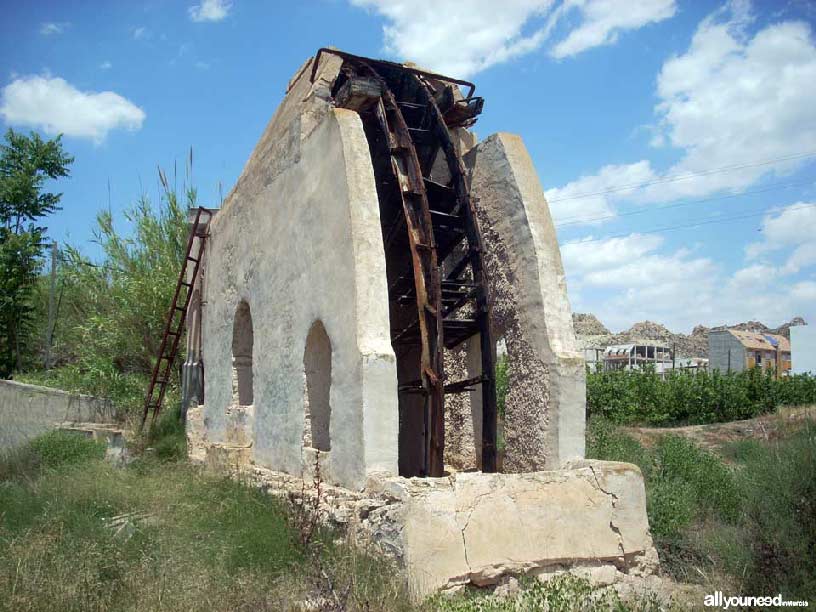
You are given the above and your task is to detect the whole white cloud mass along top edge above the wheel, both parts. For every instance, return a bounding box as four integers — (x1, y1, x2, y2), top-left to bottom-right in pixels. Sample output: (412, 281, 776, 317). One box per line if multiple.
(350, 0, 675, 78)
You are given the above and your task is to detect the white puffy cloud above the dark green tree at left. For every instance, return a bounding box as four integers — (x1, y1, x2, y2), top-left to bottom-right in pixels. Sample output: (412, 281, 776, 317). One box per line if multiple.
(0, 75, 145, 143)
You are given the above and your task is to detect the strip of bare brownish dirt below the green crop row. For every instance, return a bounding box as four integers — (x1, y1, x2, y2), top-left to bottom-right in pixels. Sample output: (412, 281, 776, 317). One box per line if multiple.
(622, 405, 816, 452)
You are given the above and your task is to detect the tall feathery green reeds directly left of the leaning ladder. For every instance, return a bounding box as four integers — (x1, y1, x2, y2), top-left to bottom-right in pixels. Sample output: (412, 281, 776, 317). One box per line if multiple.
(57, 190, 190, 374)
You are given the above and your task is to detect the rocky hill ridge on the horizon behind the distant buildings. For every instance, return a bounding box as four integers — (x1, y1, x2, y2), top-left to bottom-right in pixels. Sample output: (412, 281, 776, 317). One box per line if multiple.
(572, 312, 805, 357)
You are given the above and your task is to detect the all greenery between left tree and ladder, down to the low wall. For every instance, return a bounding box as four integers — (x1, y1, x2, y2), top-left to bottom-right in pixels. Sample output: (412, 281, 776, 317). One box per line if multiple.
(15, 175, 191, 413)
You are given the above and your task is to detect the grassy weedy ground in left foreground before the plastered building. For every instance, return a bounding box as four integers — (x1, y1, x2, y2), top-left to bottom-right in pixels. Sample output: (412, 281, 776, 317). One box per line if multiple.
(0, 434, 407, 611)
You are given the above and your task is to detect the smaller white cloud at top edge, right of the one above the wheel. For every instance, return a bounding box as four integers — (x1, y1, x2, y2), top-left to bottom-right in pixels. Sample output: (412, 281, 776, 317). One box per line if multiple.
(550, 0, 677, 58)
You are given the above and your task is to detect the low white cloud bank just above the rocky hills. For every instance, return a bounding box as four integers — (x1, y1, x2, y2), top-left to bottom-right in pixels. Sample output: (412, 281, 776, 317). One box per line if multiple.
(562, 234, 816, 333)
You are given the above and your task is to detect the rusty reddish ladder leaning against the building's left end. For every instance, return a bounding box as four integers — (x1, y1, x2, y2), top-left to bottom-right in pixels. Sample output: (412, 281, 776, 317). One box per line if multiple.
(141, 206, 212, 428)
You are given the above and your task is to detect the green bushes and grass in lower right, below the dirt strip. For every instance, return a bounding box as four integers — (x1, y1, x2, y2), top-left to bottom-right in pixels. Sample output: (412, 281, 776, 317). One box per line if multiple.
(587, 417, 816, 600)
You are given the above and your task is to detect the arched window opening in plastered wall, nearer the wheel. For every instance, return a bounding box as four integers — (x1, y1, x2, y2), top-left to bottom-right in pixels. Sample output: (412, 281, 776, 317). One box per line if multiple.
(303, 321, 332, 452)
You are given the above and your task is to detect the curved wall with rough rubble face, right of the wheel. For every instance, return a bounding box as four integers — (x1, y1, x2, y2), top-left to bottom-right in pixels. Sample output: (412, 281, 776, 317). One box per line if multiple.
(446, 133, 586, 472)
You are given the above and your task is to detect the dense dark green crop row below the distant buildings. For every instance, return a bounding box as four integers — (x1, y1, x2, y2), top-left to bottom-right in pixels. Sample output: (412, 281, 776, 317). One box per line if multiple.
(587, 369, 816, 425)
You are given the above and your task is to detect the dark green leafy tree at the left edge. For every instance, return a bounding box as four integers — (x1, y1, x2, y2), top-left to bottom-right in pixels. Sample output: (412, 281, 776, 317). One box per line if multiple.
(0, 129, 74, 377)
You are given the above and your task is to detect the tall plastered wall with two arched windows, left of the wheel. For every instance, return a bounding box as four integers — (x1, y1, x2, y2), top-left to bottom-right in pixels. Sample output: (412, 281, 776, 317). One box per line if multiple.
(200, 56, 398, 488)
